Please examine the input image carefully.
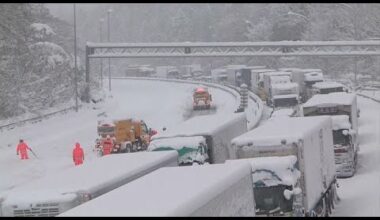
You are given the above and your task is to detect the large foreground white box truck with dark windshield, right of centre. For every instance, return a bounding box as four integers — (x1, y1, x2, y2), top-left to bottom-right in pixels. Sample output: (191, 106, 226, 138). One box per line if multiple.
(227, 116, 336, 216)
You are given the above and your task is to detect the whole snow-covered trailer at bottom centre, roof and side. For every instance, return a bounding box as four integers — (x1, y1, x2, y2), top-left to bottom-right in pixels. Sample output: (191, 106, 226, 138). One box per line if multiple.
(60, 163, 255, 217)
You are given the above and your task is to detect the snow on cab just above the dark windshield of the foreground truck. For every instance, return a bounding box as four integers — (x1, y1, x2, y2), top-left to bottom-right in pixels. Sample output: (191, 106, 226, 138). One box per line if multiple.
(226, 155, 301, 186)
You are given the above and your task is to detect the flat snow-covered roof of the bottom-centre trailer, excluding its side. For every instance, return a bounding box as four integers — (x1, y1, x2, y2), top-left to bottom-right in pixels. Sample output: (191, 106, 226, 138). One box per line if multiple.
(60, 163, 251, 216)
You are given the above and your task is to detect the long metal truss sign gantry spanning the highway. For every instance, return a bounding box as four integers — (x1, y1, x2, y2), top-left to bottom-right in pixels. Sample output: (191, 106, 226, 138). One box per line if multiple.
(86, 40, 380, 101)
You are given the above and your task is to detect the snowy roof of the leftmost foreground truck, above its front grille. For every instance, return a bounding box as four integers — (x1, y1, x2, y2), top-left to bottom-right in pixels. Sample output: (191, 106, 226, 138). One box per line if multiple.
(3, 151, 178, 204)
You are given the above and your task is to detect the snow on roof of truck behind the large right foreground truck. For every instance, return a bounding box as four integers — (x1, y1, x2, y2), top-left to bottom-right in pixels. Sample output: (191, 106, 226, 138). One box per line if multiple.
(303, 92, 356, 108)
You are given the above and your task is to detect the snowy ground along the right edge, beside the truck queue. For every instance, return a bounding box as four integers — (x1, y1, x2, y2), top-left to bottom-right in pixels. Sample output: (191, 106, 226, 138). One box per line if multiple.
(333, 96, 380, 216)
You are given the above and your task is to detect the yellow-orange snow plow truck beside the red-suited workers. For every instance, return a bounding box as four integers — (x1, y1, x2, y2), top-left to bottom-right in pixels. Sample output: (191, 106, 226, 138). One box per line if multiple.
(95, 118, 157, 153)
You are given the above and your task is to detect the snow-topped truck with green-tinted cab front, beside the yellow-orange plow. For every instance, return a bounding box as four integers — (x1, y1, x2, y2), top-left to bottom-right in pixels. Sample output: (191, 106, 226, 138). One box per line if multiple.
(148, 112, 247, 166)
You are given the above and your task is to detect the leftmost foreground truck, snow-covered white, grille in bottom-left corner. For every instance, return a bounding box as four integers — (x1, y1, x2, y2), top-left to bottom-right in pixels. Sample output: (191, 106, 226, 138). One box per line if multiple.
(0, 151, 178, 216)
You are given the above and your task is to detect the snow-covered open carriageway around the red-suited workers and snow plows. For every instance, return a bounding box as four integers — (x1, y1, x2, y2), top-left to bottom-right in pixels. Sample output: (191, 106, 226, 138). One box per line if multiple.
(0, 80, 238, 192)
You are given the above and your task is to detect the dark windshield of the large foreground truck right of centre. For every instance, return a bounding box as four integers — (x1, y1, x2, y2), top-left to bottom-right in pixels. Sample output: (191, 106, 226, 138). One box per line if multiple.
(254, 185, 293, 215)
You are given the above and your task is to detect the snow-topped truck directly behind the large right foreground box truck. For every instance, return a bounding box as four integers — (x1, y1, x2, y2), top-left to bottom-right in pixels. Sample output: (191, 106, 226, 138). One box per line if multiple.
(303, 92, 359, 177)
